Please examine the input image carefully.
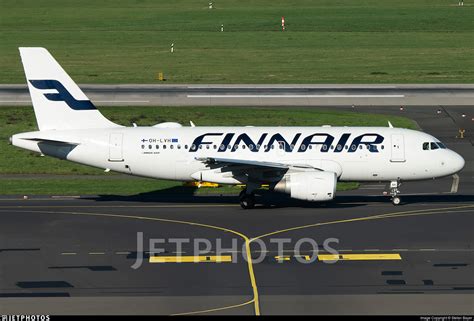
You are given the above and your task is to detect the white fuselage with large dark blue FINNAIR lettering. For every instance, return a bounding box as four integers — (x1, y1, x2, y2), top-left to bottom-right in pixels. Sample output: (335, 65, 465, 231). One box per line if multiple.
(12, 126, 464, 184)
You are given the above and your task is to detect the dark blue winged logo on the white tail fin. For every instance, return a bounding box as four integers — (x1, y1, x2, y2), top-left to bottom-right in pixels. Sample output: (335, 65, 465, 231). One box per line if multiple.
(30, 80, 96, 110)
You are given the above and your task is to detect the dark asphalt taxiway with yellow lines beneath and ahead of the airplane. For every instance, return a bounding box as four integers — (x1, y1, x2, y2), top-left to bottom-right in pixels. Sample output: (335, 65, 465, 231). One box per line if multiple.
(0, 94, 474, 315)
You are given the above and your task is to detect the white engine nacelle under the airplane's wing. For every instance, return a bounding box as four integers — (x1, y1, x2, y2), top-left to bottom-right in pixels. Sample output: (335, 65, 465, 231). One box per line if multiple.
(274, 171, 337, 202)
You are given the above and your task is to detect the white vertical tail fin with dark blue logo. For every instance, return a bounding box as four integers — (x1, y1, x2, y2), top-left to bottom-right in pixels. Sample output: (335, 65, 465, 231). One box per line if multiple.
(19, 48, 119, 130)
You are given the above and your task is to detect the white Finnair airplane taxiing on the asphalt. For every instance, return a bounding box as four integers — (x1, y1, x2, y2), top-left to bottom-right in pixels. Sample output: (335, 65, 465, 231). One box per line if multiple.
(10, 47, 465, 209)
